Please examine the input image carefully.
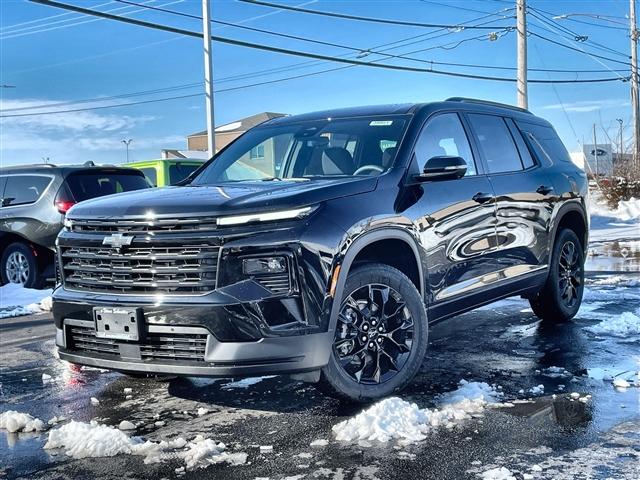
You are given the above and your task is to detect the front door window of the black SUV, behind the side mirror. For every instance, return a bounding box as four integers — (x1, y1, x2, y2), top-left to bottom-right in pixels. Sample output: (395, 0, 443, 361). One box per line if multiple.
(416, 113, 477, 175)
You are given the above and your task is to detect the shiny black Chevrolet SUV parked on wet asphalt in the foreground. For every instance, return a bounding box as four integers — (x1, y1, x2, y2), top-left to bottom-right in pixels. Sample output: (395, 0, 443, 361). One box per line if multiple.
(53, 98, 588, 401)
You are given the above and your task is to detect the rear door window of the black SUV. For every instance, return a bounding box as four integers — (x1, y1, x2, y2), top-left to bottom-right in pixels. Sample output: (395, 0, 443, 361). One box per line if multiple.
(469, 113, 522, 173)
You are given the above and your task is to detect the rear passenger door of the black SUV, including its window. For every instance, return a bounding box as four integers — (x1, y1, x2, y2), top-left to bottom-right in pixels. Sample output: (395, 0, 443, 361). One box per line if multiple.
(468, 113, 554, 278)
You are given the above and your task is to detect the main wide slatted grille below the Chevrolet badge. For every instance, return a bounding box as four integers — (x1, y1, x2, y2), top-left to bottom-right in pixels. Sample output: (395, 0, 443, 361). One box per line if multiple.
(60, 245, 220, 294)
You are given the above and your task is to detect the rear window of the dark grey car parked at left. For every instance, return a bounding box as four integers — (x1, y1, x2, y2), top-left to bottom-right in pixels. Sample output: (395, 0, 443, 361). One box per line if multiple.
(67, 170, 149, 202)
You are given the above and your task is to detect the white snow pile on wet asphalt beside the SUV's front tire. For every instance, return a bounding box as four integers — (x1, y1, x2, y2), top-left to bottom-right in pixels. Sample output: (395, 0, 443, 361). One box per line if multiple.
(333, 380, 500, 442)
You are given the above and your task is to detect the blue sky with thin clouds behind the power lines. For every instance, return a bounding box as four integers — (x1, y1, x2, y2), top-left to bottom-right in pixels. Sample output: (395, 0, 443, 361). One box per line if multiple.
(0, 0, 631, 166)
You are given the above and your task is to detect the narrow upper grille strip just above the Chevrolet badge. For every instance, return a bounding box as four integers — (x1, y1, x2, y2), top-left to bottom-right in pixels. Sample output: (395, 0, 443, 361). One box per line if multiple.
(70, 217, 217, 234)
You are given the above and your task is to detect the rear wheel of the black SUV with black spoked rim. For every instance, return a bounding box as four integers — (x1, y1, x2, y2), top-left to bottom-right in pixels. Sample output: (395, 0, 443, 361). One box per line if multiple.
(529, 229, 584, 323)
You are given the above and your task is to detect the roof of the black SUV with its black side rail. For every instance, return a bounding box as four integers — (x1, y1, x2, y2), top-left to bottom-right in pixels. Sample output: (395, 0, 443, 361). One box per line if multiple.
(262, 97, 546, 126)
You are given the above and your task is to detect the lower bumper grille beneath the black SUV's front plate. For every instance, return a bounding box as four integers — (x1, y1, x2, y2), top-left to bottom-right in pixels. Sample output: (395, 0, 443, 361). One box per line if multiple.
(66, 325, 207, 362)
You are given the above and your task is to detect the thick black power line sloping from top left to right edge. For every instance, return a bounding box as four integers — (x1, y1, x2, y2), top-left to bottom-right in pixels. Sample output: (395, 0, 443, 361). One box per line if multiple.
(30, 0, 632, 83)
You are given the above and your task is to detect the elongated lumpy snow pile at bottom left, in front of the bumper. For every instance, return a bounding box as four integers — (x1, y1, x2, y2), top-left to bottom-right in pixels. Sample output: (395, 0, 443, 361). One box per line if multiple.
(44, 421, 247, 470)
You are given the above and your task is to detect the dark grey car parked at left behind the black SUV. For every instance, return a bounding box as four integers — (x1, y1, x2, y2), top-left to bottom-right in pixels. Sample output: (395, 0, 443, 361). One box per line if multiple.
(0, 162, 148, 288)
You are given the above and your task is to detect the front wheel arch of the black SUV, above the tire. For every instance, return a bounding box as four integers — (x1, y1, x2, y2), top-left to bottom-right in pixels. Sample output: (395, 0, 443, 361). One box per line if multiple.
(329, 228, 425, 331)
